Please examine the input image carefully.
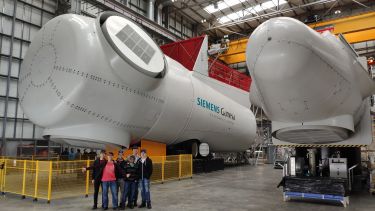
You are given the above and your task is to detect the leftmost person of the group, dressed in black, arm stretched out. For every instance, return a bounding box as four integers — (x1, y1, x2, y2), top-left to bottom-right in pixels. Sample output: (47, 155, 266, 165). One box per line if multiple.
(83, 150, 107, 210)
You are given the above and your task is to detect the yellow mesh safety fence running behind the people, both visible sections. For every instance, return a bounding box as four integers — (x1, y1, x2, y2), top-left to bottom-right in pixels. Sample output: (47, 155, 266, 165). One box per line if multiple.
(0, 154, 193, 203)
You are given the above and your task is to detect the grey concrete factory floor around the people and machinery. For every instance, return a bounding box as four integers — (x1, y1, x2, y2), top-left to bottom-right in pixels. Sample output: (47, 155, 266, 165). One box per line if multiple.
(0, 165, 375, 211)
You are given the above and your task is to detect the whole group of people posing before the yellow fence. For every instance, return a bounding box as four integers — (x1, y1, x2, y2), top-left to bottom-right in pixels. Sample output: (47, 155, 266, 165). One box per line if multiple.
(83, 147, 153, 210)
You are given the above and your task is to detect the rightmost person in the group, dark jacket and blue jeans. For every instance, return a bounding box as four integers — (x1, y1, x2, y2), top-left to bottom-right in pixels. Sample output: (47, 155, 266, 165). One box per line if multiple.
(138, 149, 152, 209)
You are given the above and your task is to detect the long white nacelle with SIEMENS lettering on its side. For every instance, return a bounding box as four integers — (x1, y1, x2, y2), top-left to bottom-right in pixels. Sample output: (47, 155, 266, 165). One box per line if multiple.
(19, 12, 256, 151)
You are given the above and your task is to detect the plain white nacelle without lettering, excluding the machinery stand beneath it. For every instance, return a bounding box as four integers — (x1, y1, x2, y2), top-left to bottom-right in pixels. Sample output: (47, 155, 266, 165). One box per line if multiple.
(246, 17, 374, 143)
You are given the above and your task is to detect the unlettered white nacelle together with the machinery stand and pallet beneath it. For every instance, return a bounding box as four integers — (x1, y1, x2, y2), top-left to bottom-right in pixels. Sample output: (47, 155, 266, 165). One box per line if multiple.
(246, 17, 375, 206)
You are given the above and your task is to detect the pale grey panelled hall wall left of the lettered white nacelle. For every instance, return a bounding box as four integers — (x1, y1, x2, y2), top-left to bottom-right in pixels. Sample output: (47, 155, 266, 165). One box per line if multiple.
(0, 0, 57, 155)
